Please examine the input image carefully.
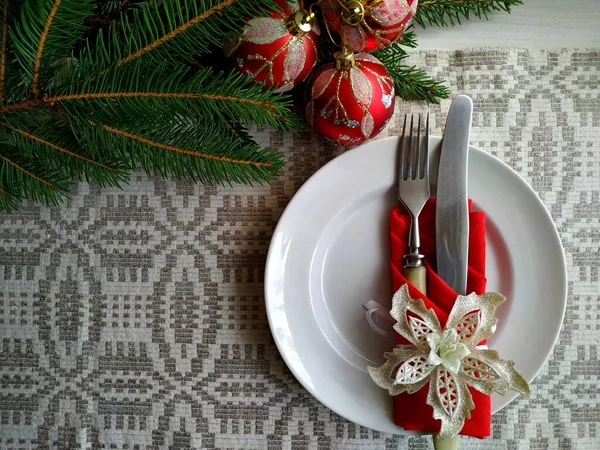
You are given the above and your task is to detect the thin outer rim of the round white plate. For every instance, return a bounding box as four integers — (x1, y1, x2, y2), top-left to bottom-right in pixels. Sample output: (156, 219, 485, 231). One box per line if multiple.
(263, 135, 569, 435)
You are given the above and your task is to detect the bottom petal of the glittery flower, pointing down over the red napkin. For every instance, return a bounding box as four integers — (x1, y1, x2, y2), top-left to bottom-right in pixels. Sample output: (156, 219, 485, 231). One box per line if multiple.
(427, 366, 475, 439)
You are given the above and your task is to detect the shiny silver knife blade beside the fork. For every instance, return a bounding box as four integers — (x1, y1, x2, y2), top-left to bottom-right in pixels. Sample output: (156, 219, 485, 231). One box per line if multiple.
(435, 95, 473, 294)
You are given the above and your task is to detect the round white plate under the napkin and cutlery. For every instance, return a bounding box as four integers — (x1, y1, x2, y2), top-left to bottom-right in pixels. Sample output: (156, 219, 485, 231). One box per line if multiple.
(265, 138, 567, 433)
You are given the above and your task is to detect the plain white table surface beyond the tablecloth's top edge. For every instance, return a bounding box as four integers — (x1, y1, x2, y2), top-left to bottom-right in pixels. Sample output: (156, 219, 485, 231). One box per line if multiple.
(417, 0, 600, 50)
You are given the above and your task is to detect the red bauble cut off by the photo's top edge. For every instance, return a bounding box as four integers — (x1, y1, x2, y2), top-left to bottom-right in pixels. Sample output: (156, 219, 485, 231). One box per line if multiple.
(323, 0, 418, 52)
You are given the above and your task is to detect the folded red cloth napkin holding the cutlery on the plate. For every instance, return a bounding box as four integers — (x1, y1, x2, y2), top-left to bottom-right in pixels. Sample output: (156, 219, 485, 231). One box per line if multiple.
(390, 200, 491, 437)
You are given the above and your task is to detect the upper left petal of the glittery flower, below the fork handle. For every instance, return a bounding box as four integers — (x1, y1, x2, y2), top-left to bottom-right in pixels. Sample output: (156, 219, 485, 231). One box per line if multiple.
(391, 284, 442, 352)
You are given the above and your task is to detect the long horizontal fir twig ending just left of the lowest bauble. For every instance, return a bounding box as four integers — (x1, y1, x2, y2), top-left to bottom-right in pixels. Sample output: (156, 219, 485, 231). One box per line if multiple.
(41, 57, 301, 131)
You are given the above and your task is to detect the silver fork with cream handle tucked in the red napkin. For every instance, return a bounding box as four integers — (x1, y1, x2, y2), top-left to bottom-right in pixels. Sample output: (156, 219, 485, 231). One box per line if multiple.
(398, 113, 430, 295)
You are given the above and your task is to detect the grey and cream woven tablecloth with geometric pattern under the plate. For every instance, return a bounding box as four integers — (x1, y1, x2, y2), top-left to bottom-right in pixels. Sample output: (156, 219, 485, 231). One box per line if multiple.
(0, 49, 600, 450)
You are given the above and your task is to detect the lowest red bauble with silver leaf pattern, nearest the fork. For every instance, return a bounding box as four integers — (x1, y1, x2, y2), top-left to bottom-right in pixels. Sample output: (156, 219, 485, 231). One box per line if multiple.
(306, 51, 395, 145)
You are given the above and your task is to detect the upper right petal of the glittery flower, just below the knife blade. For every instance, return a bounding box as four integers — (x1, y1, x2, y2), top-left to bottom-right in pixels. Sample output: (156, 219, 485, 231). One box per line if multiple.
(446, 292, 506, 349)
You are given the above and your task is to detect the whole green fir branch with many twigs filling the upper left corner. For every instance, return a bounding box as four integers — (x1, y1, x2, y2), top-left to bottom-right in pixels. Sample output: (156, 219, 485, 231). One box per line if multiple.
(0, 0, 300, 210)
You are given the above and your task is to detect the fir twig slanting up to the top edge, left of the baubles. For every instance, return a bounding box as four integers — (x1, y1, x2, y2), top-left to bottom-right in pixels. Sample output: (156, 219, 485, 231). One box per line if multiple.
(113, 0, 278, 64)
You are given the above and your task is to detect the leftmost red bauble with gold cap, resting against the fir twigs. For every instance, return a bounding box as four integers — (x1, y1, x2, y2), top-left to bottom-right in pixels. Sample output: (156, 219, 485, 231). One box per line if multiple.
(224, 0, 320, 92)
